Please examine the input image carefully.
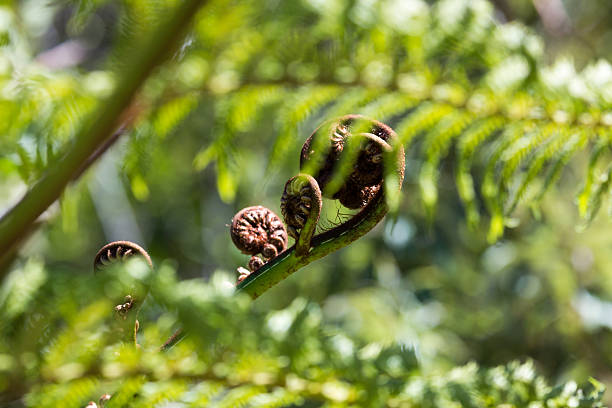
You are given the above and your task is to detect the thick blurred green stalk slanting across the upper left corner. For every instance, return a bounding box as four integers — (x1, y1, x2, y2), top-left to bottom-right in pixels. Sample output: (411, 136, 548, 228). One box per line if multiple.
(0, 0, 205, 279)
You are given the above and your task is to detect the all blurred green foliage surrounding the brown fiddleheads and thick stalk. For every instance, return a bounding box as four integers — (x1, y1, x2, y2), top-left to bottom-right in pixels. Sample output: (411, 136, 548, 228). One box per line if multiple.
(0, 0, 612, 406)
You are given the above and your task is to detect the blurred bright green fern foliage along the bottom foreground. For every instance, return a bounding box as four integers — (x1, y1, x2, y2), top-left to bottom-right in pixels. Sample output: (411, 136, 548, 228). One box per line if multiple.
(0, 260, 604, 407)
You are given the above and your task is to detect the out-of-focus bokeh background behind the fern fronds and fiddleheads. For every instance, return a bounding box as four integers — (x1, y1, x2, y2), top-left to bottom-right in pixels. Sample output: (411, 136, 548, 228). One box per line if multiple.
(0, 0, 612, 401)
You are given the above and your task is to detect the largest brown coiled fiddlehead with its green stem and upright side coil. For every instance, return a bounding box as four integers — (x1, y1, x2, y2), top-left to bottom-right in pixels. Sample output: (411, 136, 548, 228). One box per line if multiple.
(237, 115, 405, 297)
